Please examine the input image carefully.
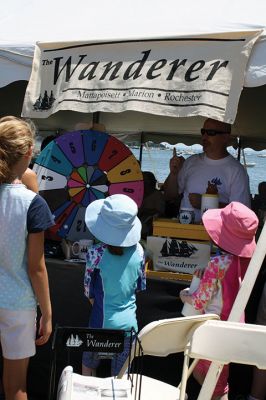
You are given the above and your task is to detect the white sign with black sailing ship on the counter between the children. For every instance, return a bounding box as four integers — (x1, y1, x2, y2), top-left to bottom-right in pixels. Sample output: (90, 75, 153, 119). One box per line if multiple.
(147, 236, 210, 274)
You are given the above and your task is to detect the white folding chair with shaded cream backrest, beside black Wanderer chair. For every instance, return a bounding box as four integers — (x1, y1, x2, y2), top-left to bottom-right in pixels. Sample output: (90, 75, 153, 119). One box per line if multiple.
(118, 314, 219, 400)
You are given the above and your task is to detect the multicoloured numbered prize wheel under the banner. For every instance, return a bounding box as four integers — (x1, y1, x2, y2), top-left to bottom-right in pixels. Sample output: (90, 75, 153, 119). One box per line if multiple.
(33, 130, 144, 241)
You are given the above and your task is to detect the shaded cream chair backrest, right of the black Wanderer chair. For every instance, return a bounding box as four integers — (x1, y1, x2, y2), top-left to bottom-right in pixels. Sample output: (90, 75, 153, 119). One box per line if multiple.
(138, 314, 219, 357)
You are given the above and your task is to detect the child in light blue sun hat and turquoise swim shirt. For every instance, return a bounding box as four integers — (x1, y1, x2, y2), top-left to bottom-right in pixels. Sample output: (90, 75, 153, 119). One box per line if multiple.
(82, 194, 146, 376)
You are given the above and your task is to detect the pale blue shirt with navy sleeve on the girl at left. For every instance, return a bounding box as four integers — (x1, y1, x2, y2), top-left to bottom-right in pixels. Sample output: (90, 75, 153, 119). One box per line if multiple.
(0, 184, 52, 310)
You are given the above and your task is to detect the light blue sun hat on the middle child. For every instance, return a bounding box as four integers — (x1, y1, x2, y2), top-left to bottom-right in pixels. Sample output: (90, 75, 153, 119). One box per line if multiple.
(85, 194, 141, 247)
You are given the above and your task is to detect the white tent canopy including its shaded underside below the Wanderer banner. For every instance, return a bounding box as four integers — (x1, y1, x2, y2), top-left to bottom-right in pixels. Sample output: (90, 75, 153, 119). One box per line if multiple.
(0, 0, 266, 148)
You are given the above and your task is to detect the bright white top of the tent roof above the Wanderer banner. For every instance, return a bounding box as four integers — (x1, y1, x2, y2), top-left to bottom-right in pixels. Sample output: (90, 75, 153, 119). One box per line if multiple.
(0, 0, 266, 86)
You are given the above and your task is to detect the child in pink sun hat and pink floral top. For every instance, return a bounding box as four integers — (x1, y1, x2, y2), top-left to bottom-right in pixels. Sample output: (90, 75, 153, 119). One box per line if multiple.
(180, 202, 258, 400)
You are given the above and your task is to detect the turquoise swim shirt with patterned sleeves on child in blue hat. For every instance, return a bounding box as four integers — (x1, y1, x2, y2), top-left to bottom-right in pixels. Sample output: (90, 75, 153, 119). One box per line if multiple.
(84, 244, 146, 331)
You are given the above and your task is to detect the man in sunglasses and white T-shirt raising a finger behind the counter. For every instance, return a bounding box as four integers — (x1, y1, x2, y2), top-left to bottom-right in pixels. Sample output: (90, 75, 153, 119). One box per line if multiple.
(164, 118, 250, 223)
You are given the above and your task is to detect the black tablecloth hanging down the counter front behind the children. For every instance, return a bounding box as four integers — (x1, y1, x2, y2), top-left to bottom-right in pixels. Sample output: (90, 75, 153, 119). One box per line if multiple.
(25, 258, 261, 400)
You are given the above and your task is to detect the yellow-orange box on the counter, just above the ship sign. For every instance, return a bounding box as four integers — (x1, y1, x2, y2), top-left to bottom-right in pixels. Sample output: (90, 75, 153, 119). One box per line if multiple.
(153, 218, 210, 241)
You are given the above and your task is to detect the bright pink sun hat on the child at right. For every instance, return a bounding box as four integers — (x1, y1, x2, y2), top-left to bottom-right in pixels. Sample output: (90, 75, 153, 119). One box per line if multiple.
(202, 201, 258, 258)
